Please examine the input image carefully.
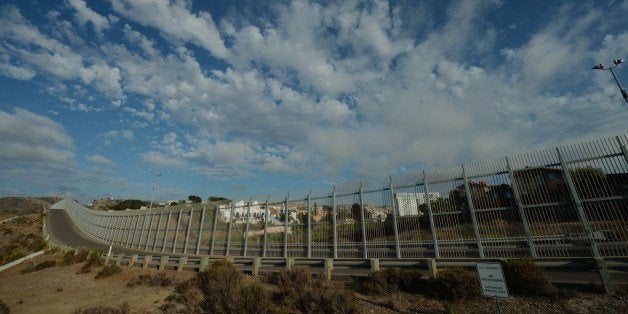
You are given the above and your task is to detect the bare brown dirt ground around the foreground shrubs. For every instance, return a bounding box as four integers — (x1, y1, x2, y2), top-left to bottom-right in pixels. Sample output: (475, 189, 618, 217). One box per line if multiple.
(0, 252, 628, 313)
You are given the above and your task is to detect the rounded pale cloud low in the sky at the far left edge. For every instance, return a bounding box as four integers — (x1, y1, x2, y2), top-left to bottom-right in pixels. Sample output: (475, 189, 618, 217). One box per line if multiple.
(0, 108, 74, 164)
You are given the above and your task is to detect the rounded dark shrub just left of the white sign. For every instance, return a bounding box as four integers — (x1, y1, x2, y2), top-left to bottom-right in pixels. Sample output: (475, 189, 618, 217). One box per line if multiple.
(427, 267, 482, 301)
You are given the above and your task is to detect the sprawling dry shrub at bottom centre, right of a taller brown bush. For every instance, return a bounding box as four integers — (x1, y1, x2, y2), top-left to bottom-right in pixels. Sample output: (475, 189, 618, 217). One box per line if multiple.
(276, 268, 357, 313)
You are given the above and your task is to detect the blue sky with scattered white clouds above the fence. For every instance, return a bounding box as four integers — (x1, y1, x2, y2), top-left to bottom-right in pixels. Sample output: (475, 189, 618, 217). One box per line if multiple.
(0, 0, 628, 202)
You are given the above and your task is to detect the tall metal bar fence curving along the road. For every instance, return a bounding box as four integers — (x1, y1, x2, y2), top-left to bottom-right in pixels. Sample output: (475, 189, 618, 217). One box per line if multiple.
(53, 135, 628, 258)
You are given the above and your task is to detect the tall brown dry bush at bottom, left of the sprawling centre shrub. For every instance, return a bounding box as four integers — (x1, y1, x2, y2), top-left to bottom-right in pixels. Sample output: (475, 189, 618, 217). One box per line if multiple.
(198, 260, 271, 313)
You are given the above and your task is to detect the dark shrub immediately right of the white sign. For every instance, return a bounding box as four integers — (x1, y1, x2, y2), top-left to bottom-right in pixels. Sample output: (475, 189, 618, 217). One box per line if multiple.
(502, 258, 556, 295)
